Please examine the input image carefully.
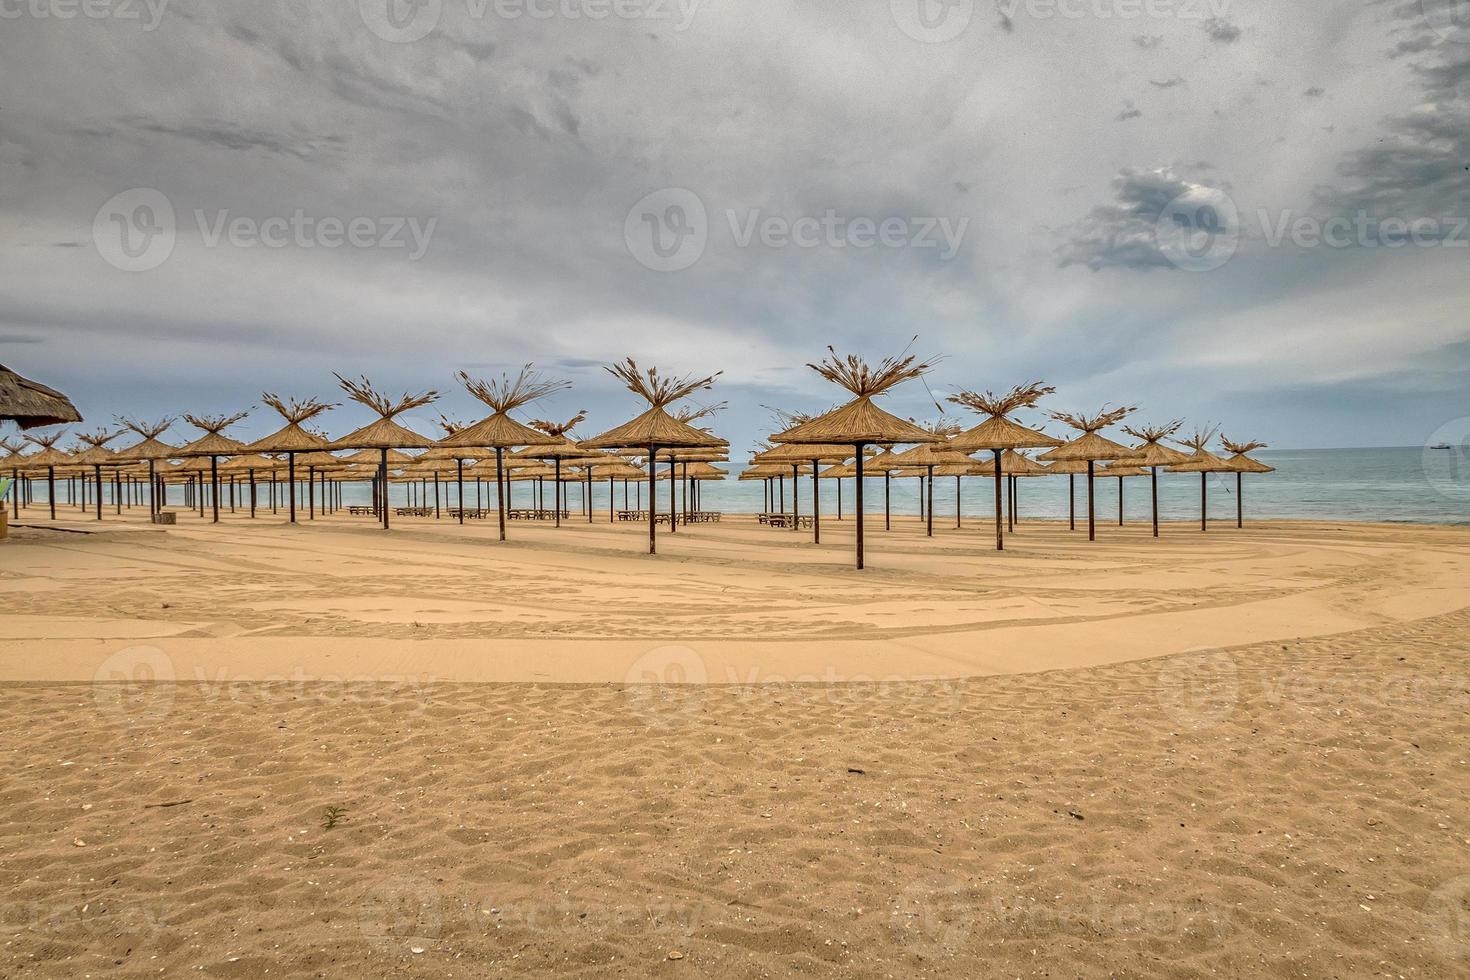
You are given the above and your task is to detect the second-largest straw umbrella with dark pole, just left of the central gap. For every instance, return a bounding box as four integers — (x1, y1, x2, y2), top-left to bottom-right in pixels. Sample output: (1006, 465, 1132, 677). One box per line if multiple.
(582, 357, 729, 554)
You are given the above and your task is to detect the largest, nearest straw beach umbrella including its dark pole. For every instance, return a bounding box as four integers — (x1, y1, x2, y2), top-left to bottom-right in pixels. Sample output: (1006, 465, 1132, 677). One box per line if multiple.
(772, 347, 944, 570)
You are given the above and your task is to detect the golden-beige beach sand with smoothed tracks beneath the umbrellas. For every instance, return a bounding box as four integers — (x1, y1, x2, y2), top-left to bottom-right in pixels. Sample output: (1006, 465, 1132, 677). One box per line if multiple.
(0, 519, 1470, 977)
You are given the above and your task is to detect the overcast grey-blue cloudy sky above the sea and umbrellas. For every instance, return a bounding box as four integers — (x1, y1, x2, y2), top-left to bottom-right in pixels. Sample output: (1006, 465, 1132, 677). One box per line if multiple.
(0, 0, 1470, 451)
